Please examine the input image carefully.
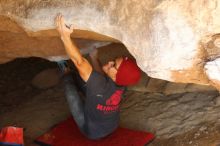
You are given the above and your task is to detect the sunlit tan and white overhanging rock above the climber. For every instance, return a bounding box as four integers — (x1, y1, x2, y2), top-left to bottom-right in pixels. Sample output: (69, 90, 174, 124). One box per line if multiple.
(0, 0, 220, 89)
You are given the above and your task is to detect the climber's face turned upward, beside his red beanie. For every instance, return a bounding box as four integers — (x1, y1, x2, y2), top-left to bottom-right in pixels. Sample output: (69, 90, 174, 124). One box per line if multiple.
(102, 57, 123, 81)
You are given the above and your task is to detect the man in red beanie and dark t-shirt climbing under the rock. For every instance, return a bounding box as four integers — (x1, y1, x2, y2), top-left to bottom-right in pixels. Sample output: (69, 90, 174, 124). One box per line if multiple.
(55, 14, 141, 139)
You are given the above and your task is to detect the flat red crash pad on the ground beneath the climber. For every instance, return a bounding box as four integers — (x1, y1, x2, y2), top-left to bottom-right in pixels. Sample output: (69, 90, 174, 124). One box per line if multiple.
(36, 118, 154, 146)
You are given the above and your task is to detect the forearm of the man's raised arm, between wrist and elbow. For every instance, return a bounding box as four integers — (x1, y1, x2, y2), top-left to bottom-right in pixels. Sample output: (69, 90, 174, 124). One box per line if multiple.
(62, 37, 83, 65)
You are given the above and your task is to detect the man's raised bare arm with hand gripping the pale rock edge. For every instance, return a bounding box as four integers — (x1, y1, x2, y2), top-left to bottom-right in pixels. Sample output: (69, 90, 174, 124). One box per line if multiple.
(55, 14, 92, 82)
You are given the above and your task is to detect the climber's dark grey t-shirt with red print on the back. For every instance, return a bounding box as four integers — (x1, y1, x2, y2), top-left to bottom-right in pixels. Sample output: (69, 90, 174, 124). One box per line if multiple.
(85, 70, 124, 137)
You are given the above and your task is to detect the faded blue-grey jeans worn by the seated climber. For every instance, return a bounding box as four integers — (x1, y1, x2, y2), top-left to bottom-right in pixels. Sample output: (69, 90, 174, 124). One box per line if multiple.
(62, 73, 101, 140)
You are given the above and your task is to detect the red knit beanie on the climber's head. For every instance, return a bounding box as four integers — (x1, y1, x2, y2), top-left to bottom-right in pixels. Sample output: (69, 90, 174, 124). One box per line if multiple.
(116, 57, 141, 86)
